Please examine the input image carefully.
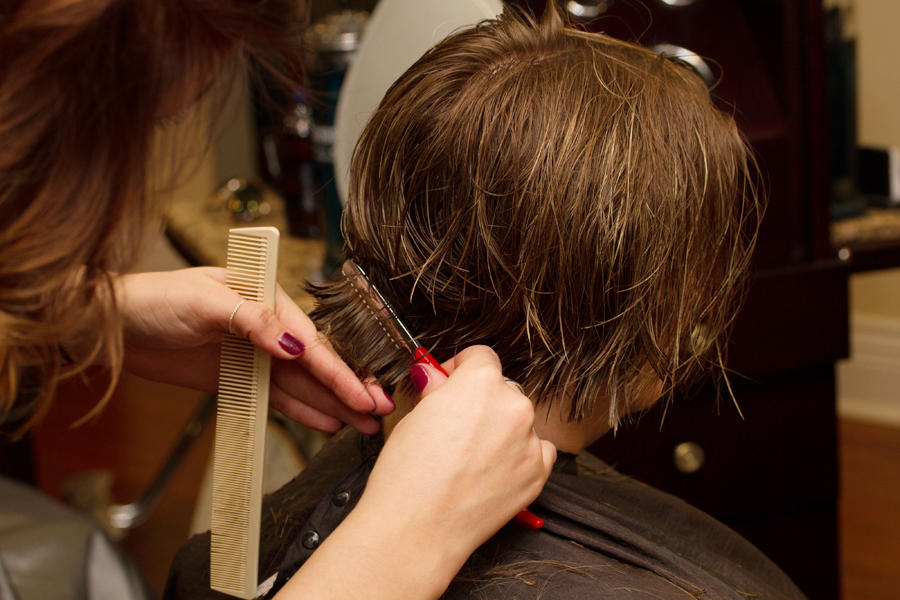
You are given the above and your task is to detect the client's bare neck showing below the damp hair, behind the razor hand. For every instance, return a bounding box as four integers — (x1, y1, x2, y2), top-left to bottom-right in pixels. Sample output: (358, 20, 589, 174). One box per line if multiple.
(382, 392, 609, 454)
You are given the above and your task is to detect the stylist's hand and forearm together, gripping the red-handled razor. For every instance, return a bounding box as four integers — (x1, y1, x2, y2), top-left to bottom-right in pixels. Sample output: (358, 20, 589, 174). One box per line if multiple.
(276, 346, 556, 600)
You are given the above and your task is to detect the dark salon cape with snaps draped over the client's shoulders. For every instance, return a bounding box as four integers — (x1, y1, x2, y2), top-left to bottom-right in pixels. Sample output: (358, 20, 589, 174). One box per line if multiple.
(164, 429, 803, 600)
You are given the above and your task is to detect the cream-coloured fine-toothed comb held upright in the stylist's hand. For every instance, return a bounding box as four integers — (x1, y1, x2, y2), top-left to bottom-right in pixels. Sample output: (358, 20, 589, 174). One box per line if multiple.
(209, 227, 278, 598)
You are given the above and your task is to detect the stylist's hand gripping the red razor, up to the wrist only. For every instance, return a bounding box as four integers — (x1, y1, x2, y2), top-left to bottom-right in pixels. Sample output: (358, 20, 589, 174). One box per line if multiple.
(366, 346, 556, 557)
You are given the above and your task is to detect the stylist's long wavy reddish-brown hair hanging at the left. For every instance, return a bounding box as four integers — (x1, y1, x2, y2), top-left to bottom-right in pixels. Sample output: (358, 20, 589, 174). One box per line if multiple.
(0, 0, 306, 434)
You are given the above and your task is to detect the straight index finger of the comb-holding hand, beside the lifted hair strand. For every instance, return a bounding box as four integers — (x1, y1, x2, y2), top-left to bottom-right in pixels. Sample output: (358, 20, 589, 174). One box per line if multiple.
(275, 285, 393, 414)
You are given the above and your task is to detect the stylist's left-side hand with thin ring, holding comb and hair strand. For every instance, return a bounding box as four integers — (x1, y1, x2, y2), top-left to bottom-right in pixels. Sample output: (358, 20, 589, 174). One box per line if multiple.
(117, 267, 393, 433)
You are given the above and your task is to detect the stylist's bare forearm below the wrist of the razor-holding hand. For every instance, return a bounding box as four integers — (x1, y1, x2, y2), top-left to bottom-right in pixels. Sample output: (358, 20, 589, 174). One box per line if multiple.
(275, 499, 468, 600)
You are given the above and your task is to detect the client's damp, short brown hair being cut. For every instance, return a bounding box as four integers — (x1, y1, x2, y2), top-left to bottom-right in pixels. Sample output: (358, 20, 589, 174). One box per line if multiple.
(314, 3, 761, 426)
